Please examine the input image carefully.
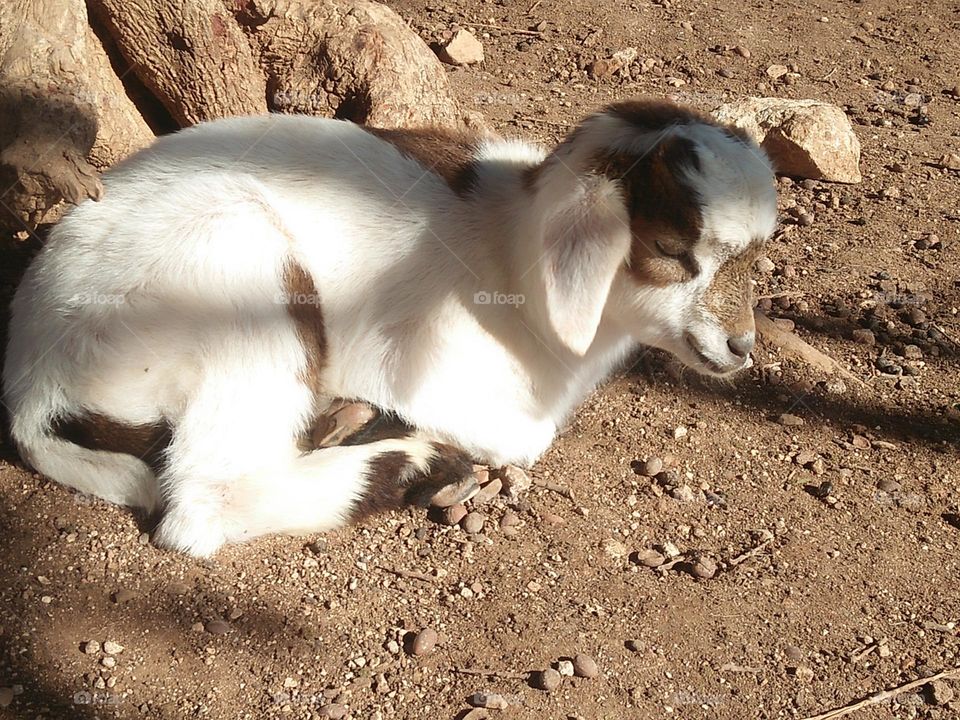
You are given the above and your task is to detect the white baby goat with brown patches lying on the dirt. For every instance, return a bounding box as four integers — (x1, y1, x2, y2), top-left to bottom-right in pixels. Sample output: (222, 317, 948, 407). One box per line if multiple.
(4, 101, 776, 555)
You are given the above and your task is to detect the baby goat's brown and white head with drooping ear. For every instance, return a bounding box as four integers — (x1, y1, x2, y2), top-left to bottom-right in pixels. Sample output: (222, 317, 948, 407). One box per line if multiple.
(531, 101, 777, 376)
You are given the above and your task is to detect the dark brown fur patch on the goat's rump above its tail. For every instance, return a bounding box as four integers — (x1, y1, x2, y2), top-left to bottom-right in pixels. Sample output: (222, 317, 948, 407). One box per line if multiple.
(53, 413, 173, 473)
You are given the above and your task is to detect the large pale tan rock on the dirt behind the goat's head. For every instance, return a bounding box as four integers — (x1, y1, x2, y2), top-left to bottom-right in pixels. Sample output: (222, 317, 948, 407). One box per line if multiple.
(713, 98, 862, 183)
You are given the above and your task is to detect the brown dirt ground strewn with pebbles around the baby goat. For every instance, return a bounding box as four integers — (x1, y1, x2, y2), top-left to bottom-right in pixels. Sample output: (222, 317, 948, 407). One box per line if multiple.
(0, 0, 960, 720)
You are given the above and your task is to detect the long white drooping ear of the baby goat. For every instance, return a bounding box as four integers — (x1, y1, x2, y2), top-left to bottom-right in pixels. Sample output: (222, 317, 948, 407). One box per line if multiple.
(543, 178, 630, 355)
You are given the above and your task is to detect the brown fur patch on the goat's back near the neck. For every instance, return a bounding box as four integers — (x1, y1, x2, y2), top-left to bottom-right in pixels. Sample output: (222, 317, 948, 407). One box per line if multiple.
(364, 127, 480, 197)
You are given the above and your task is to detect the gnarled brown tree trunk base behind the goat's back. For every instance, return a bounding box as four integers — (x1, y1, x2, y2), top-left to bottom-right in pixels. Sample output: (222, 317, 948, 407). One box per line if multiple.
(0, 0, 465, 231)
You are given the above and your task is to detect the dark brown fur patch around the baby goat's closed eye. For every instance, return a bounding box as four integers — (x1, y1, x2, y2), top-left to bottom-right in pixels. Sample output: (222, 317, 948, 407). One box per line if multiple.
(596, 136, 703, 286)
